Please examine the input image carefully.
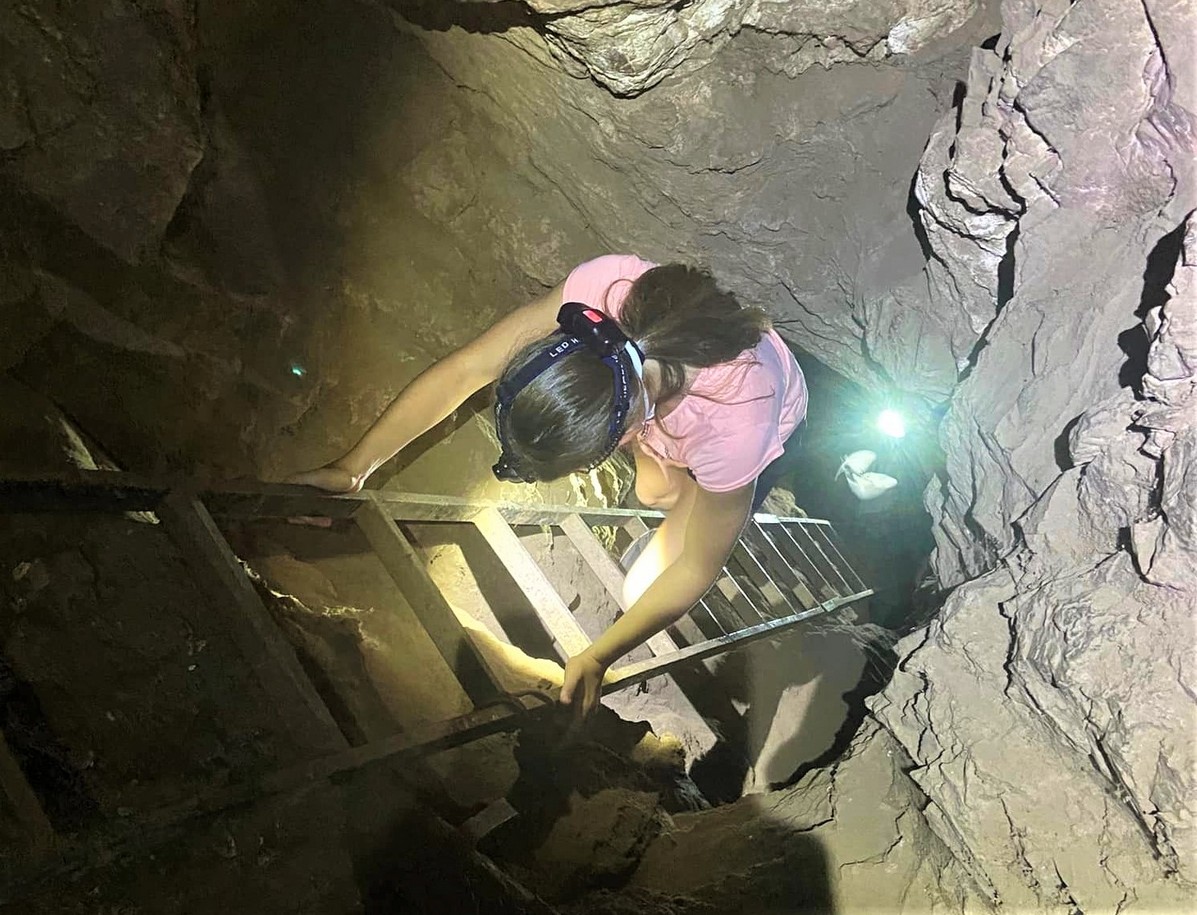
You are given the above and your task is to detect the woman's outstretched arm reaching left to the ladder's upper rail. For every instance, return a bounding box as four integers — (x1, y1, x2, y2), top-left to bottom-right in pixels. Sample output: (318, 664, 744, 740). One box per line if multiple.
(287, 284, 564, 492)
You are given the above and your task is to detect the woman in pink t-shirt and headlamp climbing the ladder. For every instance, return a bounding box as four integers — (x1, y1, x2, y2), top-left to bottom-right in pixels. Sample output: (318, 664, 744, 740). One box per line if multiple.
(290, 255, 807, 715)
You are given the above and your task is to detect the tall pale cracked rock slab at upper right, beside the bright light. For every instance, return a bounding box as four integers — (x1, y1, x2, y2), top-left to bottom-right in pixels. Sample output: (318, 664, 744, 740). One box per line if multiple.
(919, 4, 1197, 586)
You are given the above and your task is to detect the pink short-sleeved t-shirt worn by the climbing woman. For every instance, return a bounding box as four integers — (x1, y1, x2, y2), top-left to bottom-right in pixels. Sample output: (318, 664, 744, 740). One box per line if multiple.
(563, 254, 807, 492)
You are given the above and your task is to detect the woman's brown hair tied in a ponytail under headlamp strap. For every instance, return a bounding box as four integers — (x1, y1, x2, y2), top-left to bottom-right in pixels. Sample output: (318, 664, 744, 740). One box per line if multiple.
(499, 263, 770, 480)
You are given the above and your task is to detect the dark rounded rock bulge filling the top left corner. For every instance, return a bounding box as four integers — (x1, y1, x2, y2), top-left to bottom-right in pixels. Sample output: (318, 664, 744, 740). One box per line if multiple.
(0, 0, 203, 262)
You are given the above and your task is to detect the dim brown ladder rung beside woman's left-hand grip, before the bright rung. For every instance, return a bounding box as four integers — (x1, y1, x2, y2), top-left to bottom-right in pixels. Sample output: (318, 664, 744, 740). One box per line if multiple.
(353, 502, 503, 705)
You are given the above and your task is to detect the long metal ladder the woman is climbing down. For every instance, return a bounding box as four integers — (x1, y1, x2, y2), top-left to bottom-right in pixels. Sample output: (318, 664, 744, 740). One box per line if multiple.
(0, 471, 873, 867)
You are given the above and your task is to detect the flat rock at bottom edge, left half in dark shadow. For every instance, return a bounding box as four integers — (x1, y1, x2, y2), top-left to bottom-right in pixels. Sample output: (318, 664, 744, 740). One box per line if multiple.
(627, 726, 980, 915)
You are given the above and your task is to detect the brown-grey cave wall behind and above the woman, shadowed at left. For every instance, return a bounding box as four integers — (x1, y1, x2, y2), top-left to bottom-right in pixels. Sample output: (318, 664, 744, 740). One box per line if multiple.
(0, 0, 996, 471)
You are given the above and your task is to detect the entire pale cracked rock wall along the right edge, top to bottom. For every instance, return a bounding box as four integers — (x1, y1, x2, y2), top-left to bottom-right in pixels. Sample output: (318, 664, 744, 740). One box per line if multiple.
(873, 1, 1197, 913)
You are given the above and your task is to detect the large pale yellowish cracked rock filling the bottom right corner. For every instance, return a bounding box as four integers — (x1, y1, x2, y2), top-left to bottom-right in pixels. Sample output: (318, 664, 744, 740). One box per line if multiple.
(874, 553, 1193, 911)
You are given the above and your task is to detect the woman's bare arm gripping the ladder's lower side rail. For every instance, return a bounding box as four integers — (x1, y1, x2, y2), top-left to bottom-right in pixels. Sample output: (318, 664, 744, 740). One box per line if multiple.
(560, 483, 755, 715)
